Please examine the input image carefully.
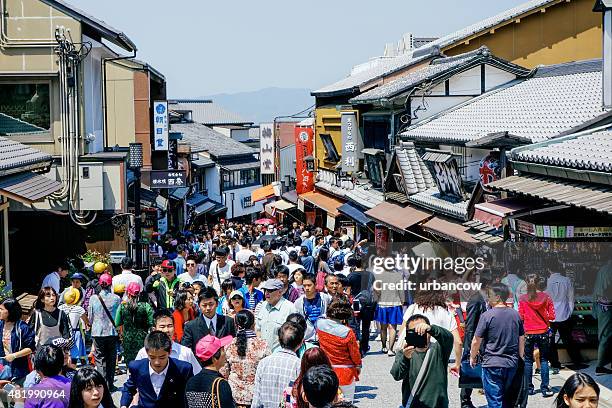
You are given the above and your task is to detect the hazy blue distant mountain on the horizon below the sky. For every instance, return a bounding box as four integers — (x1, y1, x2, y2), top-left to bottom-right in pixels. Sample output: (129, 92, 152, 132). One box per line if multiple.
(204, 88, 314, 124)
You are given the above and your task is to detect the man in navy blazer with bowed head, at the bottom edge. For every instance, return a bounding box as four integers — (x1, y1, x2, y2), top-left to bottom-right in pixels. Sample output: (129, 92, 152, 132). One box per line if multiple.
(121, 331, 193, 408)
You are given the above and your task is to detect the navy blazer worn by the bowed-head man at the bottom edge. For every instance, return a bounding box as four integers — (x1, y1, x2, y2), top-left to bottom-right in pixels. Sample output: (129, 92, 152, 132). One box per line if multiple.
(121, 358, 193, 408)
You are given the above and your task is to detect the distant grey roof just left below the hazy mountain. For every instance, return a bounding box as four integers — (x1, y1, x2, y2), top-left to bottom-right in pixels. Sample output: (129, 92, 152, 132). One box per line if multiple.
(168, 99, 253, 126)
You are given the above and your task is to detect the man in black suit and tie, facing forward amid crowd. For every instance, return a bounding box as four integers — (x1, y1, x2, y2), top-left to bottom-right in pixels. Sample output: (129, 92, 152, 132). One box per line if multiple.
(181, 287, 236, 353)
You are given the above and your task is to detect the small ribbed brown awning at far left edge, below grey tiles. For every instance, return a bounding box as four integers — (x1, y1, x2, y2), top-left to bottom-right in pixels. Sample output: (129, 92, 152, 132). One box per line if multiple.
(0, 171, 62, 204)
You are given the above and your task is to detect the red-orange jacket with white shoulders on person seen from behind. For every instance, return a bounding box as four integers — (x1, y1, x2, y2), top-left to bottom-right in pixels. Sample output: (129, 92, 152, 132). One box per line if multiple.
(317, 319, 361, 385)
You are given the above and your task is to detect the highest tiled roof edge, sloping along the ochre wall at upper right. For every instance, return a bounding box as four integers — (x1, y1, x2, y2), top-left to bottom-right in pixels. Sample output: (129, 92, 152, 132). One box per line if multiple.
(421, 0, 560, 54)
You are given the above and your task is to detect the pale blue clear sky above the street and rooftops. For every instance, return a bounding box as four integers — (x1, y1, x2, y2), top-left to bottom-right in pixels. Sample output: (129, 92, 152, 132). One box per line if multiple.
(67, 0, 523, 97)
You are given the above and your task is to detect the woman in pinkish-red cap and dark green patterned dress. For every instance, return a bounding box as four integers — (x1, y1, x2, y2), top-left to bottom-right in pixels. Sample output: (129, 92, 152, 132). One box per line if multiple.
(115, 282, 153, 361)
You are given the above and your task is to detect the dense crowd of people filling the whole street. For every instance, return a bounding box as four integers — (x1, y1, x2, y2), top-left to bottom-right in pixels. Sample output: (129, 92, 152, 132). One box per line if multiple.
(0, 223, 609, 408)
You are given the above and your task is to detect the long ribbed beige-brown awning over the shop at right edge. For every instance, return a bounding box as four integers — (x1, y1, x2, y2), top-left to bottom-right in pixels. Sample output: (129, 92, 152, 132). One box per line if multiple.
(487, 176, 612, 214)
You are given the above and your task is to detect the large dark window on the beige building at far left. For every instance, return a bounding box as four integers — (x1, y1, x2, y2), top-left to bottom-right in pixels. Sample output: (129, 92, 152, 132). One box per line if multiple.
(0, 82, 51, 136)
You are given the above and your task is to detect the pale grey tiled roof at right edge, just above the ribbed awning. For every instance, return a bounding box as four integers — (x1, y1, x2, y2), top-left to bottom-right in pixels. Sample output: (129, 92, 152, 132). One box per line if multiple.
(512, 130, 612, 173)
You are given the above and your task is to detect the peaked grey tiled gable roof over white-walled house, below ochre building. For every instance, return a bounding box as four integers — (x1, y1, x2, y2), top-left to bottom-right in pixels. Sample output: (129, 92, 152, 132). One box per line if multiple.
(349, 47, 530, 104)
